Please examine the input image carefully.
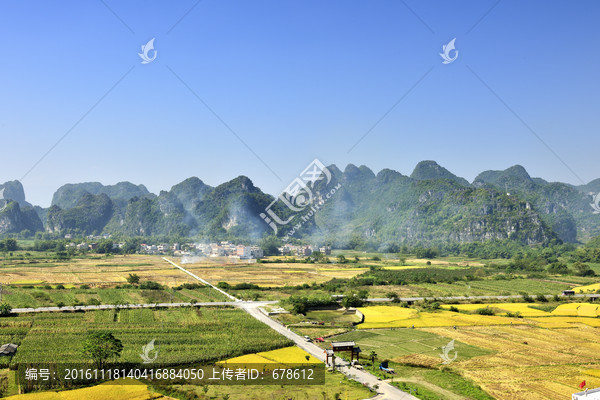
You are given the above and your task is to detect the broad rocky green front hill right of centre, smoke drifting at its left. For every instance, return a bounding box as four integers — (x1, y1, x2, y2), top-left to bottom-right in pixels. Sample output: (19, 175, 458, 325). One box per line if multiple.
(305, 162, 556, 246)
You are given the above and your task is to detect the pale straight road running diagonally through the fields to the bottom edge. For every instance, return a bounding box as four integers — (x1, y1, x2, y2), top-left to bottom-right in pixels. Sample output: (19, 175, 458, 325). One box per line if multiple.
(163, 257, 417, 400)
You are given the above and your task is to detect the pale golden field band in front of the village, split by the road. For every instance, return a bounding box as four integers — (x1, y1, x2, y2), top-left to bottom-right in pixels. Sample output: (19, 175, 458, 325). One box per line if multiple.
(0, 254, 366, 287)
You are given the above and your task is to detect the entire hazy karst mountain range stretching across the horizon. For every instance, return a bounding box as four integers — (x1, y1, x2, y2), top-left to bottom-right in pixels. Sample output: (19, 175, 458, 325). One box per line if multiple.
(0, 161, 600, 246)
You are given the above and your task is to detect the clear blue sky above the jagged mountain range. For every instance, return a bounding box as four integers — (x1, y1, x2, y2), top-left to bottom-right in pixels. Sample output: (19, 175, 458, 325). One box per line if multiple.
(0, 0, 600, 206)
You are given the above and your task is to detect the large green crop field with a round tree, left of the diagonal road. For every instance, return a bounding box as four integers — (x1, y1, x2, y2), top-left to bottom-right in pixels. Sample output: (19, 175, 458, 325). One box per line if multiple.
(0, 307, 290, 365)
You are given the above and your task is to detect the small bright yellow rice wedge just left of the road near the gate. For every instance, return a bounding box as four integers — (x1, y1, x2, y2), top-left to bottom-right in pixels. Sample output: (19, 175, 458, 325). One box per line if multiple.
(217, 346, 322, 371)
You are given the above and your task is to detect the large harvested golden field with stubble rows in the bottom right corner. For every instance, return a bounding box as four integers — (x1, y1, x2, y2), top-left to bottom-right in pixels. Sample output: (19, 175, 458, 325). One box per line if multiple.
(424, 324, 600, 400)
